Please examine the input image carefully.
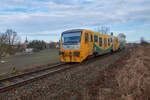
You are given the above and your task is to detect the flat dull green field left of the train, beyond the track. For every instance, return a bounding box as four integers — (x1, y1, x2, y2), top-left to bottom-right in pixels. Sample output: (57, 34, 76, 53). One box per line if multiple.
(0, 49, 59, 74)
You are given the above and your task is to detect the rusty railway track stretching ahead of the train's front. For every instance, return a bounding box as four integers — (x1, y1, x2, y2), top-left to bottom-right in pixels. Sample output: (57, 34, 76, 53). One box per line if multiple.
(0, 63, 77, 93)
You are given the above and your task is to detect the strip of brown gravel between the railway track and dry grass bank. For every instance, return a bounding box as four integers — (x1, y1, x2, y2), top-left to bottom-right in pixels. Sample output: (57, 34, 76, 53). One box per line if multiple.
(0, 46, 132, 100)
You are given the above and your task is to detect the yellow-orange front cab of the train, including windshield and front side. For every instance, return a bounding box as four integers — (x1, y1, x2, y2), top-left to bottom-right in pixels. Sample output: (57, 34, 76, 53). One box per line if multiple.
(59, 30, 93, 62)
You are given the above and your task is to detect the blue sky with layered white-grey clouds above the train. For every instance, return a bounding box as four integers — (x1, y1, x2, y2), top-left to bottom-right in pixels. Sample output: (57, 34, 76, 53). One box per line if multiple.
(0, 0, 150, 42)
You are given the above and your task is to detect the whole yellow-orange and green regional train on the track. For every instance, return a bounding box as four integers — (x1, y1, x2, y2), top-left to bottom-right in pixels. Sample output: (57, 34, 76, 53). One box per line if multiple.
(59, 29, 123, 62)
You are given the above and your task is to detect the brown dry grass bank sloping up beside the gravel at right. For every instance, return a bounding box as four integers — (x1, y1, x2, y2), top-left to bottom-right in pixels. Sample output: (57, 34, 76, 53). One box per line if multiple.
(84, 44, 150, 100)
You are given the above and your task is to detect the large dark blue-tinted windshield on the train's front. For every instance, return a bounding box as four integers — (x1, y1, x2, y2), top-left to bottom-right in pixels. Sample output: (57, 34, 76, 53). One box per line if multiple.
(62, 32, 81, 44)
